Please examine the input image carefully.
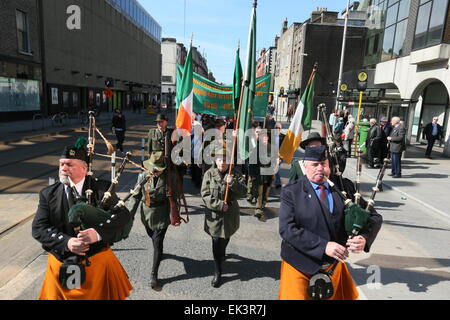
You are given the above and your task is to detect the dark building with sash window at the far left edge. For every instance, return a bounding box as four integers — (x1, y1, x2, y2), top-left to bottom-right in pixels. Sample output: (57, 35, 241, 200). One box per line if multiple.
(0, 0, 44, 121)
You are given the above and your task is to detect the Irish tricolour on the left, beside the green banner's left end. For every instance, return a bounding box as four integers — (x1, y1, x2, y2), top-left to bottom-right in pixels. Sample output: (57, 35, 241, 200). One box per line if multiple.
(175, 49, 194, 134)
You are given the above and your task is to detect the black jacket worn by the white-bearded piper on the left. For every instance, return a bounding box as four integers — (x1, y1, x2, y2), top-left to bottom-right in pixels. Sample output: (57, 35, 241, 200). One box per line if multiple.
(32, 177, 131, 261)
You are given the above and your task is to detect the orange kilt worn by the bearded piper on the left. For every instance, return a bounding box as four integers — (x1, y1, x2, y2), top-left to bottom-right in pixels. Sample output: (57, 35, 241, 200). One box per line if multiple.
(38, 248, 133, 300)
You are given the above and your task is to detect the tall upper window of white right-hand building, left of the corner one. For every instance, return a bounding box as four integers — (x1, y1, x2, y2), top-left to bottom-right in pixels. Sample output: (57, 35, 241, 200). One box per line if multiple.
(377, 0, 411, 61)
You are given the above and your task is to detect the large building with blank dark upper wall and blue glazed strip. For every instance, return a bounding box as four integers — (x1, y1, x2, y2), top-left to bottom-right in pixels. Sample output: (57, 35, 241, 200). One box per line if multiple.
(41, 0, 162, 115)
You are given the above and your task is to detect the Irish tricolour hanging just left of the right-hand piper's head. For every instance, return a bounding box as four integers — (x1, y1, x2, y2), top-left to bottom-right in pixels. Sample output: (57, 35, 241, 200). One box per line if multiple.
(280, 70, 316, 163)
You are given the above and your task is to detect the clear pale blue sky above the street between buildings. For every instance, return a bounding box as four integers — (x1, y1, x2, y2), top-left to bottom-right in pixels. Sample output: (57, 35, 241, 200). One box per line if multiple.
(139, 0, 347, 84)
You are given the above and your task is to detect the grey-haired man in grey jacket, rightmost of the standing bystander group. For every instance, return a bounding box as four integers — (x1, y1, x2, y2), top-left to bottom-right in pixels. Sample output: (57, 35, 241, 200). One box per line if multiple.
(387, 117, 406, 178)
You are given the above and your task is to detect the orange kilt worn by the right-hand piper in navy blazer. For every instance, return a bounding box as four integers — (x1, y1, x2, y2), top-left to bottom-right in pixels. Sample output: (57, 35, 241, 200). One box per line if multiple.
(278, 260, 359, 300)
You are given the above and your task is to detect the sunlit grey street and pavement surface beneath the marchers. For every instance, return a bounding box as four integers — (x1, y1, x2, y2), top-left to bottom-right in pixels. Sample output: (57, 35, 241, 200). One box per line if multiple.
(0, 115, 450, 300)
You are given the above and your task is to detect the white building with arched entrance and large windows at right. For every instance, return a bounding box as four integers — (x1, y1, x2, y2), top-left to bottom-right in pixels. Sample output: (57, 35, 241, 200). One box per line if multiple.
(369, 0, 450, 156)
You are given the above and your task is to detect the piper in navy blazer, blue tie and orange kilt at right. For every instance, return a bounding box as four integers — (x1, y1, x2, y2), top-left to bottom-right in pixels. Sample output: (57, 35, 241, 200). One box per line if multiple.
(278, 146, 382, 300)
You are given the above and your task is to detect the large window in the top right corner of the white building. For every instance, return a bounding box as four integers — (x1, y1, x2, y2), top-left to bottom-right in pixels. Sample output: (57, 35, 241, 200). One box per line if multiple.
(413, 0, 448, 49)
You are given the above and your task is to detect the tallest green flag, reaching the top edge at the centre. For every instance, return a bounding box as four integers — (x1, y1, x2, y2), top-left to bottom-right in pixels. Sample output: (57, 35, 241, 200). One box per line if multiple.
(238, 1, 256, 160)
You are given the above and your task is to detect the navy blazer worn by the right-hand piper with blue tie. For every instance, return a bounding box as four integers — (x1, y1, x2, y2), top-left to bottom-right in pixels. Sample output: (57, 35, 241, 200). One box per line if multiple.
(279, 176, 383, 275)
